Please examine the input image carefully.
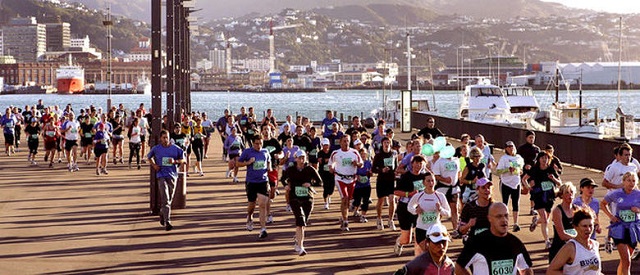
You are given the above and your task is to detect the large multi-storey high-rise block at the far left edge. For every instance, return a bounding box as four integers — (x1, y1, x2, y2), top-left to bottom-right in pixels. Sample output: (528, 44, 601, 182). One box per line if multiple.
(2, 17, 47, 62)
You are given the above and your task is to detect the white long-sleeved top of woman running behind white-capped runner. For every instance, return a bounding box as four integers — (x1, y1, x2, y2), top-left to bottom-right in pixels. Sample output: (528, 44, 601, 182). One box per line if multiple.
(407, 191, 451, 230)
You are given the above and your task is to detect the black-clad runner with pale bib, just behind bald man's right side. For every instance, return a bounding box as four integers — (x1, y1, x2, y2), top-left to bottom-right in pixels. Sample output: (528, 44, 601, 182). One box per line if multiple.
(522, 151, 562, 249)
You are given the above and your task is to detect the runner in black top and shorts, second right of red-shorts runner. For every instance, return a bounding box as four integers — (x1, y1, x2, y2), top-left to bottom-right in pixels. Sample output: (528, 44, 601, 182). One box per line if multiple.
(371, 137, 398, 231)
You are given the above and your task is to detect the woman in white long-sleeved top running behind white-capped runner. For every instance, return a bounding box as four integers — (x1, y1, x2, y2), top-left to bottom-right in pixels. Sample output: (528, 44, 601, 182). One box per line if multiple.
(407, 172, 451, 256)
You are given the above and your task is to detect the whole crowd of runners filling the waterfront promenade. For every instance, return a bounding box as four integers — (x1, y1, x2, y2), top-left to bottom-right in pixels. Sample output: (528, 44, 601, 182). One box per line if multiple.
(0, 102, 640, 274)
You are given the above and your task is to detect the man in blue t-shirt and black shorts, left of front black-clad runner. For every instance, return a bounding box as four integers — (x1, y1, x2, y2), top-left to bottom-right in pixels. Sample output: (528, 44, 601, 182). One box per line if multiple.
(237, 136, 271, 239)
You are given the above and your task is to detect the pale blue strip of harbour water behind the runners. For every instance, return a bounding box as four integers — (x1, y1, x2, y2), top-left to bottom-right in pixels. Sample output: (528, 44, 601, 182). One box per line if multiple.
(0, 90, 640, 121)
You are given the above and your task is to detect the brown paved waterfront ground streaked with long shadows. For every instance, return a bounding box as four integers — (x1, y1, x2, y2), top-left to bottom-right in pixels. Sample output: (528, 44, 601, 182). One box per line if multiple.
(0, 130, 640, 274)
